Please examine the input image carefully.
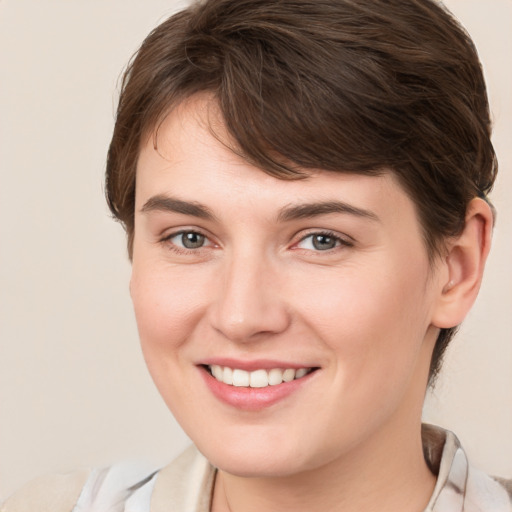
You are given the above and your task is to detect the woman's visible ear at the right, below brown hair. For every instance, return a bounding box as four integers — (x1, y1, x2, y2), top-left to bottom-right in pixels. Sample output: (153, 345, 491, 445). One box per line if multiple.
(432, 198, 493, 329)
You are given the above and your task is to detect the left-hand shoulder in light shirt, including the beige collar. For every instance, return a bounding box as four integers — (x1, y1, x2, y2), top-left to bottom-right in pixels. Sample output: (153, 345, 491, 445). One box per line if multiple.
(0, 446, 215, 512)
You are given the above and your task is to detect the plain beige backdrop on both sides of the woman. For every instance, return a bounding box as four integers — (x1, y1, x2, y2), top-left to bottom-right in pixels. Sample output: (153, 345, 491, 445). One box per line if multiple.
(0, 0, 512, 497)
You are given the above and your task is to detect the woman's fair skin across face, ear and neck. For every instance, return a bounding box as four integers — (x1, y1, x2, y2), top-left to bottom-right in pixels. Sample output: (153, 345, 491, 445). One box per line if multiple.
(130, 96, 492, 512)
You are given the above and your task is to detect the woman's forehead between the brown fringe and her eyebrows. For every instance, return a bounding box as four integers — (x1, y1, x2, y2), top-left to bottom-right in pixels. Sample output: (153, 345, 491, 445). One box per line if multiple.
(136, 95, 417, 234)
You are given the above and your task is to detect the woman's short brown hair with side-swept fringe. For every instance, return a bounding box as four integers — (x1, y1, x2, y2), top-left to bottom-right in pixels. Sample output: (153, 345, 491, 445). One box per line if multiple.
(106, 0, 497, 381)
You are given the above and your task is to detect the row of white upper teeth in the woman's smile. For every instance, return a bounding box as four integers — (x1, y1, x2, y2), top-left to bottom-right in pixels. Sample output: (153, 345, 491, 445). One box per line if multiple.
(205, 364, 310, 388)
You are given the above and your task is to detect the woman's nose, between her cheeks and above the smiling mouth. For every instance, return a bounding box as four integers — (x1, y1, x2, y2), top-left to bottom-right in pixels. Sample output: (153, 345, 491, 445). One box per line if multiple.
(210, 256, 290, 343)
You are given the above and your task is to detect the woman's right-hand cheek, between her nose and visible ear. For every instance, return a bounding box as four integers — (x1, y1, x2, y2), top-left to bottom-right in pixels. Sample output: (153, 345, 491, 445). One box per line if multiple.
(290, 264, 429, 379)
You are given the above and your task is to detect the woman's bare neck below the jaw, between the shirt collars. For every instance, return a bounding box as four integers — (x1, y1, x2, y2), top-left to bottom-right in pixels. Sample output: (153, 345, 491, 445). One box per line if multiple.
(212, 421, 435, 512)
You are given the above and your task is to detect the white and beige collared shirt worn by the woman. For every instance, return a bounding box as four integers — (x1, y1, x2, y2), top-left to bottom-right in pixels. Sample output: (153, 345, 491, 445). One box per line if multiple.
(0, 425, 512, 512)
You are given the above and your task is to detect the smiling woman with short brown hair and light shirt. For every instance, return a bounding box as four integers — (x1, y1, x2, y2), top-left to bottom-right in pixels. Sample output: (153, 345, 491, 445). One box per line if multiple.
(5, 0, 512, 512)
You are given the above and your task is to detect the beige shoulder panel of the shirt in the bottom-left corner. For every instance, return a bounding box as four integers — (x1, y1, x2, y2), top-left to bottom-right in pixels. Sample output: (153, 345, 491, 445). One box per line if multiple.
(0, 470, 91, 512)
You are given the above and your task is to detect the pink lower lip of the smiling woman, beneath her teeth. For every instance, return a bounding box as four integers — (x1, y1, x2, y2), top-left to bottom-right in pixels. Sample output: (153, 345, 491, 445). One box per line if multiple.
(200, 367, 316, 411)
